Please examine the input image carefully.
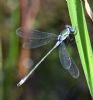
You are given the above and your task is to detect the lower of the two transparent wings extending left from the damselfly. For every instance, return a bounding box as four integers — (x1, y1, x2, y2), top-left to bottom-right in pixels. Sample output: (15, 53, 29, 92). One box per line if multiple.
(23, 38, 55, 48)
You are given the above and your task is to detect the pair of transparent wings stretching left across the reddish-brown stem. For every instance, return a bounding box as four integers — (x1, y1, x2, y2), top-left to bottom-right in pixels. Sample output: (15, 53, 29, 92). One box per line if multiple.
(16, 28, 57, 48)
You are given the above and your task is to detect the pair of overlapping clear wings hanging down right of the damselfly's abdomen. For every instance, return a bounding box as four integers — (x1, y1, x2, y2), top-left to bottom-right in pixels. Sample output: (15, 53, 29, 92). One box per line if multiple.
(59, 42, 79, 78)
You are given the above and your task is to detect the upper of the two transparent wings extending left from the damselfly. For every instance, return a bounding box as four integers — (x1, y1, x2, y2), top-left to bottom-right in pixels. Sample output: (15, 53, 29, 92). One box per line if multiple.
(16, 28, 57, 40)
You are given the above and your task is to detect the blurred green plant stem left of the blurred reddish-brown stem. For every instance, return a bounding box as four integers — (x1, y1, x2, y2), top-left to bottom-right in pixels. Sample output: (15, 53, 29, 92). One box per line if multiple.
(3, 9, 19, 100)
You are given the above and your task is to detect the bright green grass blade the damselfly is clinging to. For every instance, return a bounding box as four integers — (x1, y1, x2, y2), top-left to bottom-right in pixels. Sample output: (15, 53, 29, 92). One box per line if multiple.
(67, 0, 93, 98)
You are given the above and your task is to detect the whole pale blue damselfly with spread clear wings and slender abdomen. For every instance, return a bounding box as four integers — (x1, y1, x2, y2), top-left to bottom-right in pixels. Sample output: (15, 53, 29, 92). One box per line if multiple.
(16, 25, 79, 86)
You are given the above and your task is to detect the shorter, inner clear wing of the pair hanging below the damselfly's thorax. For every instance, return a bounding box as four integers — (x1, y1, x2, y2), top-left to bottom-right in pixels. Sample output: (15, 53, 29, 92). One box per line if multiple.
(59, 42, 71, 69)
